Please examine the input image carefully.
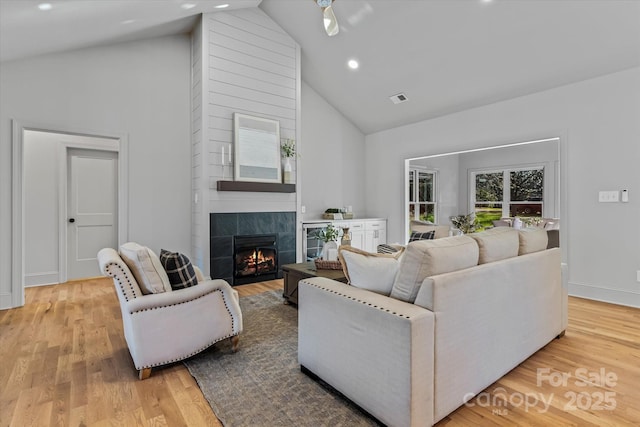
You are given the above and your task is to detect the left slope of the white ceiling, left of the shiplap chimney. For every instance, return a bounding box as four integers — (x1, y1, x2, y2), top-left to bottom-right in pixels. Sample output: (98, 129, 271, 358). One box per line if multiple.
(0, 0, 260, 62)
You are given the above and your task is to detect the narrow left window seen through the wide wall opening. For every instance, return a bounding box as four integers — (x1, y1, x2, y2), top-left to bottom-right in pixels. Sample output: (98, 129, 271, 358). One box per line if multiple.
(409, 169, 437, 223)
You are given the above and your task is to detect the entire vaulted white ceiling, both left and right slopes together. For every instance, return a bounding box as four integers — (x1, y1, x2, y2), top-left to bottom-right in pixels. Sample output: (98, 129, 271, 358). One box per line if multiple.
(0, 0, 640, 134)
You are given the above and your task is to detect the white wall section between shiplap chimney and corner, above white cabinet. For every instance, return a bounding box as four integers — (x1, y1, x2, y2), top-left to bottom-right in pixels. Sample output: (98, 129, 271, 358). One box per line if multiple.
(299, 82, 364, 220)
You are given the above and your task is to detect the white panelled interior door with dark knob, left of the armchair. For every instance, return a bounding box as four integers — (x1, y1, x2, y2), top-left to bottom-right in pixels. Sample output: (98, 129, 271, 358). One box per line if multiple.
(67, 149, 118, 280)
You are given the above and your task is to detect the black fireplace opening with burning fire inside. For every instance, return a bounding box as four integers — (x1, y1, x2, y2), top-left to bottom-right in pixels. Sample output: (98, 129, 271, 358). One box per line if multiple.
(233, 234, 278, 285)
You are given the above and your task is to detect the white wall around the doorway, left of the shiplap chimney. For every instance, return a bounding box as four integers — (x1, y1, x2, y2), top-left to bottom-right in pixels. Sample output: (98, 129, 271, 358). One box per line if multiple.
(0, 35, 191, 307)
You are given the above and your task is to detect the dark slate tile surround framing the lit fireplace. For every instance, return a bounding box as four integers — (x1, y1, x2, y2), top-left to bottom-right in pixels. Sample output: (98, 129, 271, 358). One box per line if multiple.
(209, 212, 296, 285)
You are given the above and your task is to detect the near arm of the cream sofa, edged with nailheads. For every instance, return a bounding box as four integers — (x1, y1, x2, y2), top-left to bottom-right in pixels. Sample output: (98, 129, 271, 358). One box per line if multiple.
(298, 277, 434, 426)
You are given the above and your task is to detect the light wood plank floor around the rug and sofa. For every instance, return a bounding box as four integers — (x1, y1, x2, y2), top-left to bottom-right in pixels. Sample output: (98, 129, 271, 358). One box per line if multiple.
(0, 279, 640, 427)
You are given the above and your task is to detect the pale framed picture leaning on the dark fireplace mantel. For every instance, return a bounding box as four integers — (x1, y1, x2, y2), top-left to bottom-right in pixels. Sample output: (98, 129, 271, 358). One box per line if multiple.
(233, 113, 282, 184)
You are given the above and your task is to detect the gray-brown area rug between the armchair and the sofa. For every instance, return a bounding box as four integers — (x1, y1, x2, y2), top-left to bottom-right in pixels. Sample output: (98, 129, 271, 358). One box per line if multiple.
(184, 291, 380, 427)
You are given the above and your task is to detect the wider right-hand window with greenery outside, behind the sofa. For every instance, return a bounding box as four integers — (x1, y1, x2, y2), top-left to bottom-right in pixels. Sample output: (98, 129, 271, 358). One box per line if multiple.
(472, 167, 544, 227)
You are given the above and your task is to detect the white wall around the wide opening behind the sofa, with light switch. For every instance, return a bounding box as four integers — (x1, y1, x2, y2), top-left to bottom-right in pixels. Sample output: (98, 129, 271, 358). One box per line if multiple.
(366, 68, 640, 307)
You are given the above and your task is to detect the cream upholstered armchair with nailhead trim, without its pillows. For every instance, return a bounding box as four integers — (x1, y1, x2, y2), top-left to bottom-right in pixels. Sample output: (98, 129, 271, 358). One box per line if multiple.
(98, 248, 242, 379)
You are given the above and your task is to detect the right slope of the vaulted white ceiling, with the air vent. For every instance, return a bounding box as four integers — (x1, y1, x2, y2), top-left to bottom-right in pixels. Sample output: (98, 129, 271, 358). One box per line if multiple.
(260, 0, 640, 134)
